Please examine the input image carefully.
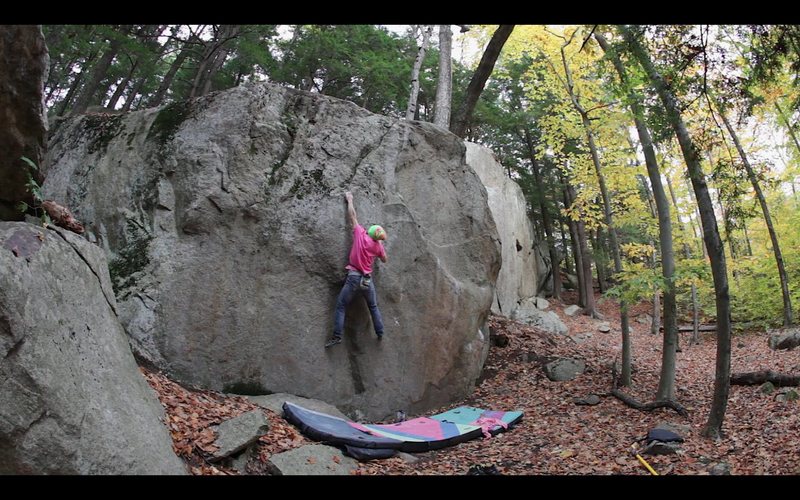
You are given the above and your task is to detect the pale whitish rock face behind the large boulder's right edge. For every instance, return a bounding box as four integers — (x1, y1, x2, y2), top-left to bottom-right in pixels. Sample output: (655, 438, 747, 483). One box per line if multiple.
(466, 142, 547, 318)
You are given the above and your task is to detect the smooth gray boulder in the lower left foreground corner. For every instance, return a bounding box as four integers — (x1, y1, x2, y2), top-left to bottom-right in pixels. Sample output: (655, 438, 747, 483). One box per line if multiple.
(0, 222, 186, 474)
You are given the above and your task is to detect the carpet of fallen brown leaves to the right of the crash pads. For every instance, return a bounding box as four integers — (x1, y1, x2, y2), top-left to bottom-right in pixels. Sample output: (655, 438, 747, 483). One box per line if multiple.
(358, 296, 800, 475)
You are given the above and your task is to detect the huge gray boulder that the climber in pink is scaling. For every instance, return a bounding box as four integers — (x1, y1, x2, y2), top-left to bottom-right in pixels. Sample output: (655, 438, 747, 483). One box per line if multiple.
(44, 84, 500, 420)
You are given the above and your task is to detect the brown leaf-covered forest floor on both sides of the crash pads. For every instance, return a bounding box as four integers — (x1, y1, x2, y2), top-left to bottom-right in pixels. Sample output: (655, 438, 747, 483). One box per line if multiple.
(143, 296, 800, 476)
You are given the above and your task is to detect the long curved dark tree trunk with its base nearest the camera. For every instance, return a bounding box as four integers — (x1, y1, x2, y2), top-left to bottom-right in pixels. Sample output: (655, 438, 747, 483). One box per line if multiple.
(617, 26, 731, 438)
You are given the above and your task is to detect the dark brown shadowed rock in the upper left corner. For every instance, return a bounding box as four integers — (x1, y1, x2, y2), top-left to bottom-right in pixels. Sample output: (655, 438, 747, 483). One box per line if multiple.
(0, 24, 49, 220)
